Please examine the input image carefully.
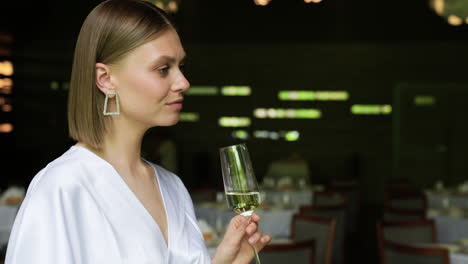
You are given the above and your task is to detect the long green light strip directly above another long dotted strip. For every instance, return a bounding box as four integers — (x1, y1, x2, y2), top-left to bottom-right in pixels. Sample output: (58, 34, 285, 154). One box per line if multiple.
(278, 90, 349, 101)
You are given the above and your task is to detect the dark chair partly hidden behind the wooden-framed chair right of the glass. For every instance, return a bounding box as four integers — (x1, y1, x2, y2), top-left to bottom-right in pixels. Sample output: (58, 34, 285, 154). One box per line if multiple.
(299, 205, 347, 264)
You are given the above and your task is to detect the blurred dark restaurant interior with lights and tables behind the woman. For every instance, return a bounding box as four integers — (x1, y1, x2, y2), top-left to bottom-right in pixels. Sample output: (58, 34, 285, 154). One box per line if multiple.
(0, 0, 468, 264)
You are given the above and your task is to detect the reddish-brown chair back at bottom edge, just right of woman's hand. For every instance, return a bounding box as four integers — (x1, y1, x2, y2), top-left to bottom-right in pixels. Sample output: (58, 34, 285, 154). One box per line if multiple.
(252, 240, 315, 264)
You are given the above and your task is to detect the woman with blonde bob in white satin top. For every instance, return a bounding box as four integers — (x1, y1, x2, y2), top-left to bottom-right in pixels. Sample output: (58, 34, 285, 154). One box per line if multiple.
(6, 0, 271, 264)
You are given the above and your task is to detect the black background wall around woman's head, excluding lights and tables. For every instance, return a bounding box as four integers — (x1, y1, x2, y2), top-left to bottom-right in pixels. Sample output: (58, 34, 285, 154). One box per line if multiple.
(0, 0, 468, 205)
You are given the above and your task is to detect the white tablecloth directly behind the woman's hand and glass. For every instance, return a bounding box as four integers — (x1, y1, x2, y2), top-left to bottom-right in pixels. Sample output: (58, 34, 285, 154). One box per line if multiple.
(195, 205, 298, 238)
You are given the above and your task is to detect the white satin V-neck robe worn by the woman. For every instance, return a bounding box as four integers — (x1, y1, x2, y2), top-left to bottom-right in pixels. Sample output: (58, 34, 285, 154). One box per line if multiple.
(5, 146, 211, 264)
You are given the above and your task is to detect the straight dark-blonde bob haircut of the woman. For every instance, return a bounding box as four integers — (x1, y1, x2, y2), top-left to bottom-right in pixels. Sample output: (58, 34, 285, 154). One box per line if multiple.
(68, 0, 175, 149)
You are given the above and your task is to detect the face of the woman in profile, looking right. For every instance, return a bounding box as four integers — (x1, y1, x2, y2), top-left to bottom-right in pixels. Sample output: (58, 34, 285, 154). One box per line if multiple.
(110, 29, 190, 128)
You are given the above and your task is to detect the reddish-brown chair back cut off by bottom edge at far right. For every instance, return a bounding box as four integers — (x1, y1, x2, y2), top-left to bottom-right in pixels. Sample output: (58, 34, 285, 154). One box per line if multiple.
(382, 241, 450, 264)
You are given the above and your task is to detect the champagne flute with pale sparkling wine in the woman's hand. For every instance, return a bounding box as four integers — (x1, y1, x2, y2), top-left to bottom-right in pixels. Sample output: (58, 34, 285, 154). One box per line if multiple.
(219, 144, 260, 264)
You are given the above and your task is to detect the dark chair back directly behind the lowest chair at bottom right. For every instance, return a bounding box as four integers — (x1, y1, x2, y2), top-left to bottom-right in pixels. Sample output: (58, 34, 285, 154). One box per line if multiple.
(377, 220, 437, 262)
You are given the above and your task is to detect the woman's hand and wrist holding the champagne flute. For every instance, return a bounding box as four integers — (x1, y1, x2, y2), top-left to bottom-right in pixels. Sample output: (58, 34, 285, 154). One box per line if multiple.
(213, 213, 271, 264)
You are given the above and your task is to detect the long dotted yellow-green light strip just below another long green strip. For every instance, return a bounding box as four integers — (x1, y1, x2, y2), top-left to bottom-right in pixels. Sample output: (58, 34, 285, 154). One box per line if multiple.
(254, 108, 322, 119)
